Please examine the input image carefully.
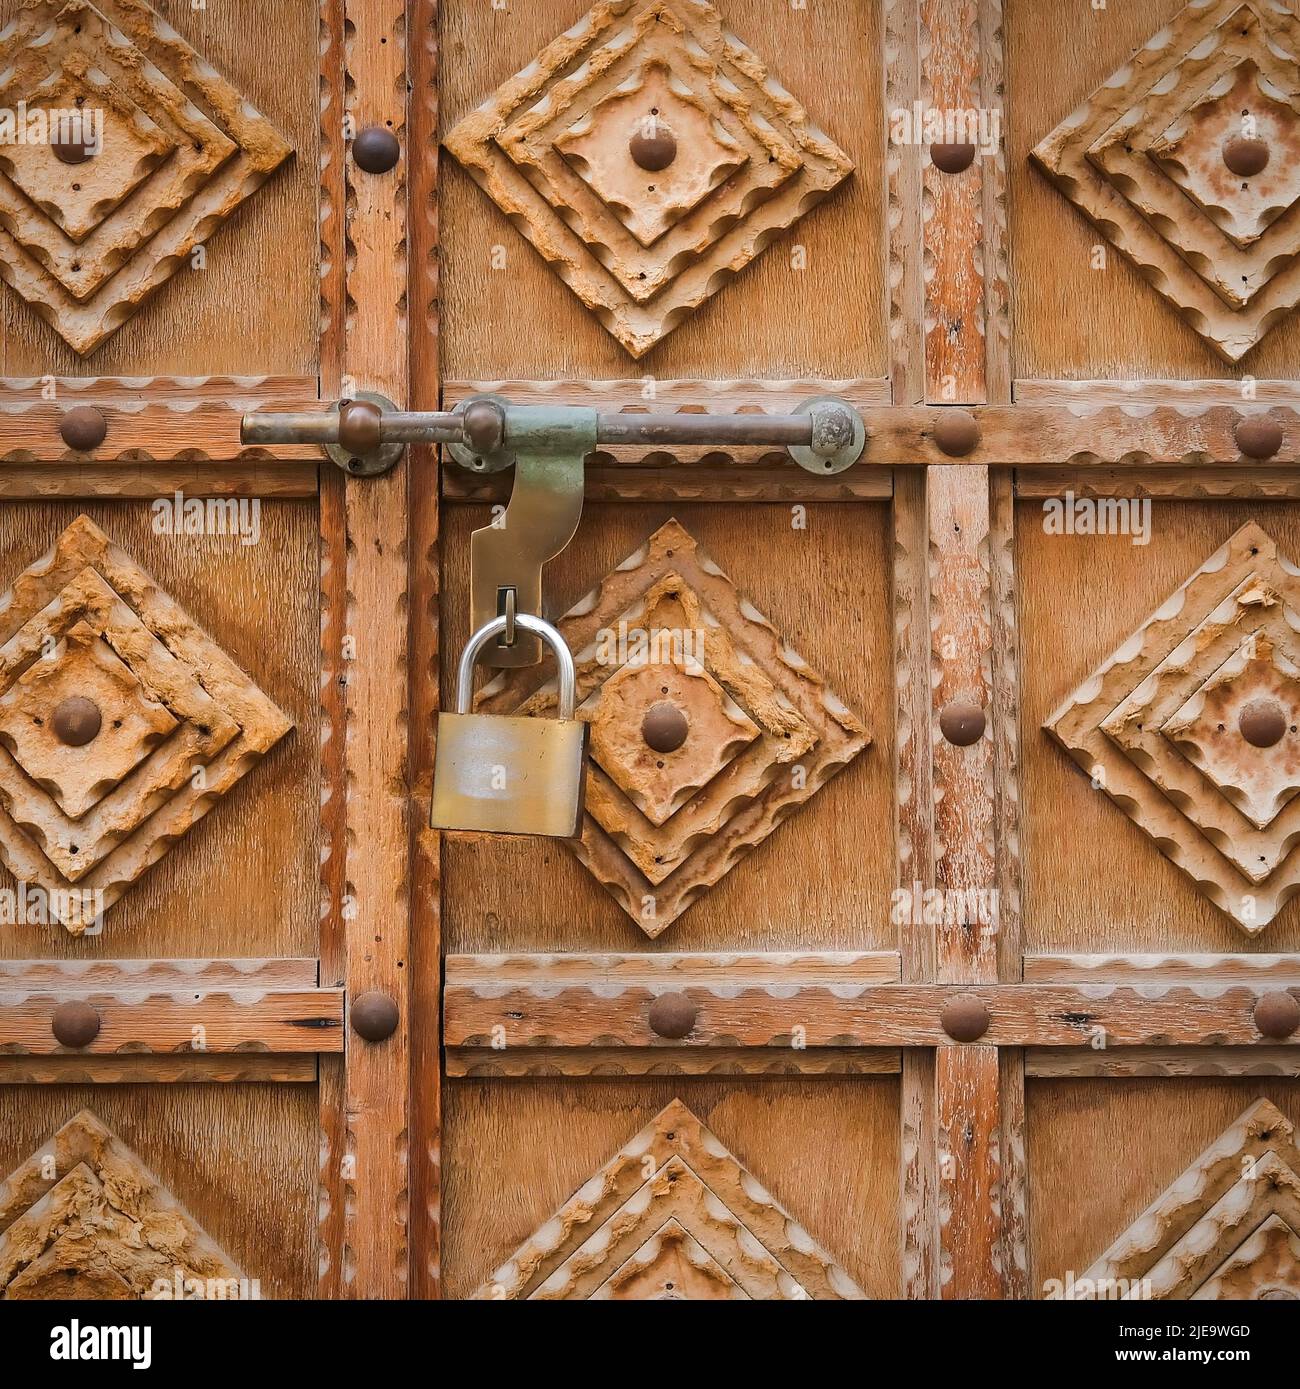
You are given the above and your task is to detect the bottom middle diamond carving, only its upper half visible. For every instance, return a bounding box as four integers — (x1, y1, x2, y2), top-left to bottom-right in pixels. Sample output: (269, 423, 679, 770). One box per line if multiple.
(475, 1100, 863, 1301)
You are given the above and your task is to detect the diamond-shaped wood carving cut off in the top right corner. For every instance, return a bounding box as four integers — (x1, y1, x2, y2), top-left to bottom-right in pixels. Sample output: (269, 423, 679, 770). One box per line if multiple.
(1033, 0, 1300, 361)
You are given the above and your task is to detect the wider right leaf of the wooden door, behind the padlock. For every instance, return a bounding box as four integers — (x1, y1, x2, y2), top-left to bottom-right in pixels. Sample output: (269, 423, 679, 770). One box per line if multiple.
(430, 0, 1300, 1299)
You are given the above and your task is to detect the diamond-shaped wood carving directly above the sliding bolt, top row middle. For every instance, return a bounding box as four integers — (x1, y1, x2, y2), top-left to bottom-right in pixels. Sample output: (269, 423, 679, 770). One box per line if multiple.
(444, 0, 853, 357)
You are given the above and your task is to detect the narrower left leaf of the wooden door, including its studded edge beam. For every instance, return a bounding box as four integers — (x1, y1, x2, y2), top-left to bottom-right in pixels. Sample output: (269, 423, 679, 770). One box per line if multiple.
(0, 0, 408, 1299)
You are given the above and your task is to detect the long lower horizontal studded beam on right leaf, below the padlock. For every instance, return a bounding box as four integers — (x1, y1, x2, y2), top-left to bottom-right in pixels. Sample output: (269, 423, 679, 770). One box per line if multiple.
(444, 956, 1300, 1051)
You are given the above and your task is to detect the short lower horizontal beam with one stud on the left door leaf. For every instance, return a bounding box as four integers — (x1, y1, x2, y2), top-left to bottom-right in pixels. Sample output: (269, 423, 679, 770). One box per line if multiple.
(0, 958, 343, 1057)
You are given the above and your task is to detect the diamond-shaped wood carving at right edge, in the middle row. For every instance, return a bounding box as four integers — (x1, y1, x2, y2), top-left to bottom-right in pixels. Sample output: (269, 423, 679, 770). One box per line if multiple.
(1044, 521, 1300, 935)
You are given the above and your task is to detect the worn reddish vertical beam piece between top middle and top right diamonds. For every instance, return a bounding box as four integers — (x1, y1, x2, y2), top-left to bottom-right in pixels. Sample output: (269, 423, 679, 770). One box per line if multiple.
(921, 0, 988, 404)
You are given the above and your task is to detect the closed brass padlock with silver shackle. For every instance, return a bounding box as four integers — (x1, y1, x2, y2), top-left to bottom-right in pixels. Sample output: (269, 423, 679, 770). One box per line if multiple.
(429, 613, 588, 839)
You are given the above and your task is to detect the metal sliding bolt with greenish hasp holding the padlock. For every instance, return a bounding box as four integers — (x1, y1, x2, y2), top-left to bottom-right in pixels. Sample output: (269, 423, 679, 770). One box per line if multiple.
(240, 394, 867, 668)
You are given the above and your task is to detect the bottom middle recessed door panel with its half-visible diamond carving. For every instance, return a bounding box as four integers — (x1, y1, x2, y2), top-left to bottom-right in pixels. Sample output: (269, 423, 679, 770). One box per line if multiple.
(444, 1076, 899, 1299)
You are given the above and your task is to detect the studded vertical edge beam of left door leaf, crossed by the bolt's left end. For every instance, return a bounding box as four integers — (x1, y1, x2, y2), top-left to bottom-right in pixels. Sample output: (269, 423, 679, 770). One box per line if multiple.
(321, 0, 411, 1297)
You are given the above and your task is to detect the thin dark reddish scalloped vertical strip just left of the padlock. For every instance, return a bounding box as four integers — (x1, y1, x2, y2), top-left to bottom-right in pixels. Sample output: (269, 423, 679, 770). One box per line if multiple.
(408, 0, 442, 1297)
